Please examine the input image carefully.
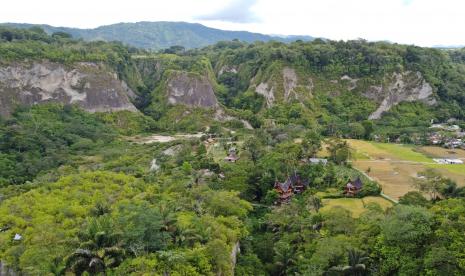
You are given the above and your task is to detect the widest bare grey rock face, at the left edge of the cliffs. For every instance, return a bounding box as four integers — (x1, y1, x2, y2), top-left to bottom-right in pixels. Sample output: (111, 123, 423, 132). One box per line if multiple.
(0, 62, 137, 116)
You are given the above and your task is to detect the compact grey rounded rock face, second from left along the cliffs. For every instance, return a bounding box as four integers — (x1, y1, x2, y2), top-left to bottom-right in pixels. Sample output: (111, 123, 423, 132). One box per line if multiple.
(167, 72, 218, 107)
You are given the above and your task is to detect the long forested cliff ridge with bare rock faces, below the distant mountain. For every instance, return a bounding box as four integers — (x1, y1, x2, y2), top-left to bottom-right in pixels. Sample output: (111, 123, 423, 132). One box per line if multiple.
(0, 27, 465, 140)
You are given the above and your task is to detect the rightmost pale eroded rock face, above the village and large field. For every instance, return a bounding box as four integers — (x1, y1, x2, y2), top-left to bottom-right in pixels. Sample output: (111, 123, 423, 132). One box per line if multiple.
(364, 71, 435, 119)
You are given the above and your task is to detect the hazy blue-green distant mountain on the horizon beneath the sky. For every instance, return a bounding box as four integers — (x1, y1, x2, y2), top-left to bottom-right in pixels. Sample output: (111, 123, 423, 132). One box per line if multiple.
(2, 22, 313, 50)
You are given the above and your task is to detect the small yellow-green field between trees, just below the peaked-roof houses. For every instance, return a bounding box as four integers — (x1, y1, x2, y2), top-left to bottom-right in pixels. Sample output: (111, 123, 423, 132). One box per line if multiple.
(321, 196, 392, 218)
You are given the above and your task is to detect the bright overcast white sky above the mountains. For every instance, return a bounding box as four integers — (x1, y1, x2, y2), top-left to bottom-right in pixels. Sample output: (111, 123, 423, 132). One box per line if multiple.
(0, 0, 465, 46)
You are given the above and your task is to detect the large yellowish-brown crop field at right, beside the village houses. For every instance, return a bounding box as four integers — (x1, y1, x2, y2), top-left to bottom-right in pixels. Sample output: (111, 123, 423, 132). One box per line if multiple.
(347, 140, 465, 199)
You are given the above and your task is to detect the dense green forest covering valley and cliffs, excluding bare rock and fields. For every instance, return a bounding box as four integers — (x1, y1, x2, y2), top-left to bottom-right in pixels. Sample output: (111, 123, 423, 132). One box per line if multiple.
(0, 28, 465, 275)
